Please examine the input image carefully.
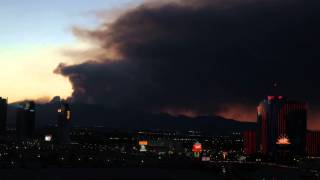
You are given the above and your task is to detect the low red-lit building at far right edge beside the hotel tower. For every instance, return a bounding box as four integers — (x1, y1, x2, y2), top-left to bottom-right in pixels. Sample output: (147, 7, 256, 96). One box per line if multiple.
(307, 131, 320, 156)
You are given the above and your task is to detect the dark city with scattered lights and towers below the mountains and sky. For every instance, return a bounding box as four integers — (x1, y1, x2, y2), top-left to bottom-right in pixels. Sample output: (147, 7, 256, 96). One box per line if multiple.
(0, 96, 320, 178)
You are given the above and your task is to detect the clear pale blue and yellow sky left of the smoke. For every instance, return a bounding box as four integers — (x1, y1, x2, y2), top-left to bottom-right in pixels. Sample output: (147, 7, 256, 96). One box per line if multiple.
(0, 0, 139, 102)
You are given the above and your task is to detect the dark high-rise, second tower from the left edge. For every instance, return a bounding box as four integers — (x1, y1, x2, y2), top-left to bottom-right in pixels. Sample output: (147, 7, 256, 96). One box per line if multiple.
(16, 101, 36, 140)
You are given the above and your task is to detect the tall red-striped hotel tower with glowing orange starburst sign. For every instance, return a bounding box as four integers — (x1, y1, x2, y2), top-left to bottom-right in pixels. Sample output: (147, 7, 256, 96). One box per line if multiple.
(257, 96, 307, 156)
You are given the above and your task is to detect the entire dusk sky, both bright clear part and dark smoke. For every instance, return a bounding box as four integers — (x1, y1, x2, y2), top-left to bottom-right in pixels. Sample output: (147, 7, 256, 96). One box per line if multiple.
(0, 0, 320, 129)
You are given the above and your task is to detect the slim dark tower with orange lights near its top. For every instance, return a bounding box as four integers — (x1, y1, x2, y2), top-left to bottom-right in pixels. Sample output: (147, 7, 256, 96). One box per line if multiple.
(57, 102, 71, 144)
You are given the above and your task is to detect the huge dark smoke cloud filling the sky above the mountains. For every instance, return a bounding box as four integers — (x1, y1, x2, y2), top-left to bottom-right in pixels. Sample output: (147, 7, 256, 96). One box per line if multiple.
(57, 0, 320, 129)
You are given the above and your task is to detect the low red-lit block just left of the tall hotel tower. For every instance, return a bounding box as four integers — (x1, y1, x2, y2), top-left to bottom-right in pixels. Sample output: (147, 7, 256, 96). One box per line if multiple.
(242, 130, 257, 155)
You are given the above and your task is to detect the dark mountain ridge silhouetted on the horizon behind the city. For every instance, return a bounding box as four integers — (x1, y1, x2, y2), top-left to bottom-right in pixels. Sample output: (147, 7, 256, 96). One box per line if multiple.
(8, 103, 255, 134)
